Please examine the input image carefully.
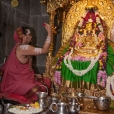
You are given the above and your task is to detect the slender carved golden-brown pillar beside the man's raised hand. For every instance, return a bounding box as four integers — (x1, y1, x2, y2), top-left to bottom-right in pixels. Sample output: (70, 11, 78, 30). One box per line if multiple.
(40, 0, 74, 93)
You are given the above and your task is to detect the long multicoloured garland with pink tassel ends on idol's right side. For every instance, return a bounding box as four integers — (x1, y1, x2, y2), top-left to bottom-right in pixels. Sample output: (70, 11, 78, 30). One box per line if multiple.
(95, 11, 107, 87)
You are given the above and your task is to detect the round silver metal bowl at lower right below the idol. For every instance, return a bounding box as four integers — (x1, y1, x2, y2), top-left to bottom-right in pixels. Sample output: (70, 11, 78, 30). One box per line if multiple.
(93, 96, 111, 110)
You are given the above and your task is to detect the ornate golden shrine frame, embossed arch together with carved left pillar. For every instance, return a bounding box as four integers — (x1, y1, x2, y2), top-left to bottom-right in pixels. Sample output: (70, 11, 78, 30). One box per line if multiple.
(40, 0, 114, 81)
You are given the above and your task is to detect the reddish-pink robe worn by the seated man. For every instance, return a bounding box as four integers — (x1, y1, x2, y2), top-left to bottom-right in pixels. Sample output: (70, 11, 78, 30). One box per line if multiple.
(0, 44, 51, 104)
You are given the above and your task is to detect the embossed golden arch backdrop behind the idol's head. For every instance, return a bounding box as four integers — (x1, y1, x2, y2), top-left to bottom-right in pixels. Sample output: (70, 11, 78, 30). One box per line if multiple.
(61, 0, 114, 45)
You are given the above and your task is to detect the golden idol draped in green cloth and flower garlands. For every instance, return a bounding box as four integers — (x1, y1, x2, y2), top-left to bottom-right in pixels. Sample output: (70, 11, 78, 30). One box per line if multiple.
(54, 0, 114, 100)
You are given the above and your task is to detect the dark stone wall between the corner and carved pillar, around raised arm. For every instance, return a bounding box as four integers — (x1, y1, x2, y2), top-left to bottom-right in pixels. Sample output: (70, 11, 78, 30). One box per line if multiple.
(30, 0, 49, 74)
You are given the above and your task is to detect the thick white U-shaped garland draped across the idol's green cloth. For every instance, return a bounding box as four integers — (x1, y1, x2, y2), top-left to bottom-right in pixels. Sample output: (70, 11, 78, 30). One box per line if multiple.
(64, 48, 100, 76)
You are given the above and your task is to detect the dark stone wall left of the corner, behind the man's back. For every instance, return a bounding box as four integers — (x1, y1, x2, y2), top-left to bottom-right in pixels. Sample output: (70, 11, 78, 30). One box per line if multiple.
(0, 0, 30, 65)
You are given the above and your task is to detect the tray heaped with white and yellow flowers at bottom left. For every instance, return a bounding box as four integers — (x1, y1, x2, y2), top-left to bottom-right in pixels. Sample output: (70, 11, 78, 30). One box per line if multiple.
(8, 102, 43, 114)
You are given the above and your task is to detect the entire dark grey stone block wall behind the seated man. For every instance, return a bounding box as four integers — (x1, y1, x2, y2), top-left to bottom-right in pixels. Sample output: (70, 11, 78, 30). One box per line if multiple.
(0, 0, 49, 73)
